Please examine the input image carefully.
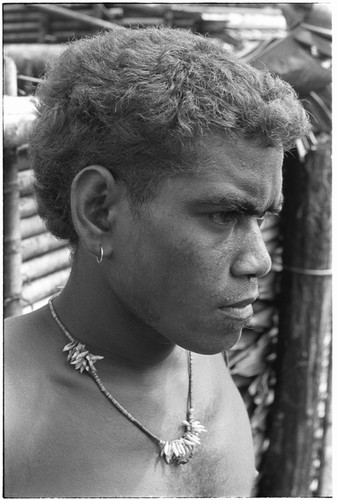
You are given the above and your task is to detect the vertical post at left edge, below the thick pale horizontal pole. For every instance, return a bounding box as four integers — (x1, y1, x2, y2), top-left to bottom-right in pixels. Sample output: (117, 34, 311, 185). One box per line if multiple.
(3, 148, 22, 318)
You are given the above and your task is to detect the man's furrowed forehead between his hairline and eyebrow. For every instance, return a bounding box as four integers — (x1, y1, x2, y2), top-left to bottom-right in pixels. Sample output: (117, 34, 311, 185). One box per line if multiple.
(177, 137, 283, 211)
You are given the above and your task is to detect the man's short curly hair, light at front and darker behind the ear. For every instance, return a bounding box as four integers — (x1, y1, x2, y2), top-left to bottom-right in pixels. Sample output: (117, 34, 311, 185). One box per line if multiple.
(30, 27, 309, 245)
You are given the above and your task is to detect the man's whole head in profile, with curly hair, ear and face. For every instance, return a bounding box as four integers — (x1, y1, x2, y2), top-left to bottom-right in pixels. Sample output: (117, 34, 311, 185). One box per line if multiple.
(31, 28, 308, 354)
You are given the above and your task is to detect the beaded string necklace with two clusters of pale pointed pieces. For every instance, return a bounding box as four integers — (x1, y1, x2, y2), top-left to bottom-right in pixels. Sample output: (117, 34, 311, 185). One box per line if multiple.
(48, 294, 207, 465)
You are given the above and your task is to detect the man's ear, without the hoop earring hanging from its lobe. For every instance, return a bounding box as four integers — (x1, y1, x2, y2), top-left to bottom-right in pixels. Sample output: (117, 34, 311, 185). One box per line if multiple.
(70, 165, 125, 257)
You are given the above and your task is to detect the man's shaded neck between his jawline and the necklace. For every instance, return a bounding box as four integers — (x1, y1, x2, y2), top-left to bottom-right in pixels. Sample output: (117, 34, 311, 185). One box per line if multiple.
(53, 252, 180, 368)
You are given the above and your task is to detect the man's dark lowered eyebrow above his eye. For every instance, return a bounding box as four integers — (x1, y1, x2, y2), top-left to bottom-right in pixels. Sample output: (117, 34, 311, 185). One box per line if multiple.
(197, 194, 283, 216)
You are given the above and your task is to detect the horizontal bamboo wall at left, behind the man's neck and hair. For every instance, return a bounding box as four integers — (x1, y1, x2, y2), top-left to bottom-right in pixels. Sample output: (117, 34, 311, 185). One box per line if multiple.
(3, 96, 70, 316)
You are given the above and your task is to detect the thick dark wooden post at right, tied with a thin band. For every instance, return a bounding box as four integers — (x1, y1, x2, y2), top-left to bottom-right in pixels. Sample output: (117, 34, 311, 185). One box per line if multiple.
(259, 134, 331, 497)
